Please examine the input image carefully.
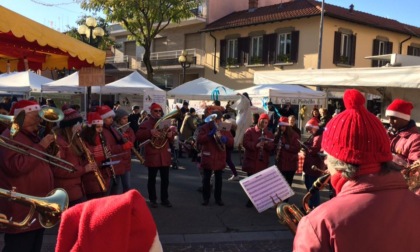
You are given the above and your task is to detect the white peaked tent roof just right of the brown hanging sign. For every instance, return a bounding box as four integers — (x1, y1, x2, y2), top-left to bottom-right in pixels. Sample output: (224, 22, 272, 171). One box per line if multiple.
(92, 72, 165, 94)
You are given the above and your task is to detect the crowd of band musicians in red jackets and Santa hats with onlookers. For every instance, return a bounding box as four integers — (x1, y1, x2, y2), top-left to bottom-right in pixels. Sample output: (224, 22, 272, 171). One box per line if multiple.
(0, 90, 420, 251)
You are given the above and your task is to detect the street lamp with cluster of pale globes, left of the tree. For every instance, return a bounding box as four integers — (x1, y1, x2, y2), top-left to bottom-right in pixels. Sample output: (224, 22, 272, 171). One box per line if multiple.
(77, 17, 105, 108)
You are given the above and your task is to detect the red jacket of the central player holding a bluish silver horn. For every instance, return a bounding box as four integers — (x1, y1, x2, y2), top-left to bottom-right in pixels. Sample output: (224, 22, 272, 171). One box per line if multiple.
(197, 123, 233, 171)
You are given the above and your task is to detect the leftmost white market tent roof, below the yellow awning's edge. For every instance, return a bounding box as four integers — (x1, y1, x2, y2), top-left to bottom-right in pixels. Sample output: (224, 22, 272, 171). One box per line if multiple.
(0, 71, 52, 93)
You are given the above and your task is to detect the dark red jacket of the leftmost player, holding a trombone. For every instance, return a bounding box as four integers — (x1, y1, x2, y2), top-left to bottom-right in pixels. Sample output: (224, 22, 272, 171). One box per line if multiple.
(0, 129, 54, 233)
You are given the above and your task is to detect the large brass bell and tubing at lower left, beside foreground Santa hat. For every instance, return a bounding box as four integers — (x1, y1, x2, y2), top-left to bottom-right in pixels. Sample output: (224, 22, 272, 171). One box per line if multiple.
(0, 188, 69, 229)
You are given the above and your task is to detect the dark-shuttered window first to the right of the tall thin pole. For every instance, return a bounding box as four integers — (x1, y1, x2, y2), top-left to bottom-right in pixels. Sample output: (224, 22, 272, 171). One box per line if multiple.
(333, 32, 356, 66)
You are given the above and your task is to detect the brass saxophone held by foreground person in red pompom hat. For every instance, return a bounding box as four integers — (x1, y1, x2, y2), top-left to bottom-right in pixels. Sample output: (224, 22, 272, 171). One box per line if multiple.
(276, 173, 330, 234)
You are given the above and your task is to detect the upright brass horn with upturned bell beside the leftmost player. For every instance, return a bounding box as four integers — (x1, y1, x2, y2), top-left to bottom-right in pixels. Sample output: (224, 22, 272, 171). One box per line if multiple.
(38, 107, 64, 155)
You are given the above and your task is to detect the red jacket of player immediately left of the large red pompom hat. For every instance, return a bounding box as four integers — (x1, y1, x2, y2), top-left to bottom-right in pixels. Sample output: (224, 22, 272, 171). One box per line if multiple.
(303, 131, 325, 177)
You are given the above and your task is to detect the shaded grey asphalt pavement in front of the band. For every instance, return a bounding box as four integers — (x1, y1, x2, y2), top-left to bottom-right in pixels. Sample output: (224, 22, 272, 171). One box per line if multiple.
(0, 152, 328, 252)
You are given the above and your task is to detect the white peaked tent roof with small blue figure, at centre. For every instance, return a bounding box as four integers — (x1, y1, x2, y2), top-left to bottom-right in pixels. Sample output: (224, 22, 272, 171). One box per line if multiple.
(167, 77, 238, 101)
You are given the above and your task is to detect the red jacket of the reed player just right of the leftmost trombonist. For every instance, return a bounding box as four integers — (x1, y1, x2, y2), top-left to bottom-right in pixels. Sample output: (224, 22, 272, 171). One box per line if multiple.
(51, 135, 87, 201)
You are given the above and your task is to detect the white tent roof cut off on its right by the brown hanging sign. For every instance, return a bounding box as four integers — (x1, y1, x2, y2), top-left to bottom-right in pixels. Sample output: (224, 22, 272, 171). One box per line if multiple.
(41, 72, 85, 93)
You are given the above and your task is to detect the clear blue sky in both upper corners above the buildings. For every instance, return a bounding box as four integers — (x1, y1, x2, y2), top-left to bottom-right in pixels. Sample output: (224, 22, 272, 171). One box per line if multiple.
(0, 0, 420, 31)
